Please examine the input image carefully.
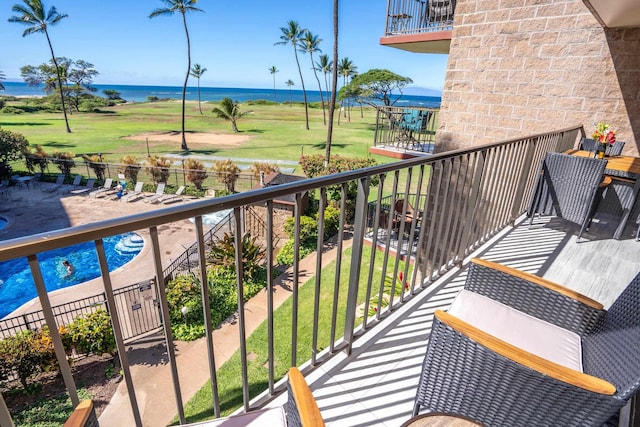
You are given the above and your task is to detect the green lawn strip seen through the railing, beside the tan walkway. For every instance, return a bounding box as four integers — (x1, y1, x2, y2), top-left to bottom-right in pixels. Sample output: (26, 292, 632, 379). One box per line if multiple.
(174, 246, 411, 423)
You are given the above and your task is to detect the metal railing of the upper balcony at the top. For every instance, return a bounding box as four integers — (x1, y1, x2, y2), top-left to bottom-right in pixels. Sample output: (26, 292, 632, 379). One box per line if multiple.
(385, 0, 456, 36)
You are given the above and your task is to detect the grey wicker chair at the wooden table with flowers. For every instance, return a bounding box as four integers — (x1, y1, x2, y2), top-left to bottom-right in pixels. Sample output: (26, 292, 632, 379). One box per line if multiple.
(527, 153, 610, 240)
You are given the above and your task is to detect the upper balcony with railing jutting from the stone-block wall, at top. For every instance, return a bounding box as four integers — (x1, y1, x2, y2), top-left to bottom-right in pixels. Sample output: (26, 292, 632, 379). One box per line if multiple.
(380, 0, 456, 53)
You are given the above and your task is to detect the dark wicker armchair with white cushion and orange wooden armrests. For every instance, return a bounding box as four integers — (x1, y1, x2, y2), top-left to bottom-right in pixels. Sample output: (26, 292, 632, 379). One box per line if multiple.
(414, 260, 640, 427)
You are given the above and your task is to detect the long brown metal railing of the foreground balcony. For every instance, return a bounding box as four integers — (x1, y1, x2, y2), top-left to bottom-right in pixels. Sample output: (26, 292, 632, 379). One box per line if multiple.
(0, 127, 582, 426)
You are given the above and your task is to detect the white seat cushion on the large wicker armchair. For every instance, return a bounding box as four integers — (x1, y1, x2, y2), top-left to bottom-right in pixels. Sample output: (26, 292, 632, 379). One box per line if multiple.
(449, 289, 583, 372)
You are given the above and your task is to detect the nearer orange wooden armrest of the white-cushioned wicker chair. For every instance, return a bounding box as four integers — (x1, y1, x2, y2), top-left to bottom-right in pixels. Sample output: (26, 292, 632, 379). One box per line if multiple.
(435, 310, 616, 396)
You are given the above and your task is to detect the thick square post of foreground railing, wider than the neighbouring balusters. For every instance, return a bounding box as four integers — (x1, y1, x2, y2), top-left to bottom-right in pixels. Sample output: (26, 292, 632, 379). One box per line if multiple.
(344, 177, 368, 354)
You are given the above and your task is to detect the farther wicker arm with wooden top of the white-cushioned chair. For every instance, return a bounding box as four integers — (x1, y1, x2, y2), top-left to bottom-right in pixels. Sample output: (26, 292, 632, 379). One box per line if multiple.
(465, 258, 606, 335)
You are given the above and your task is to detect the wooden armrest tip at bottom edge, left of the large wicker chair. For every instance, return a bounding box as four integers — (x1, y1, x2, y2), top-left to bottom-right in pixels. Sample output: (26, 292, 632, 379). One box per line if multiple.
(285, 367, 324, 427)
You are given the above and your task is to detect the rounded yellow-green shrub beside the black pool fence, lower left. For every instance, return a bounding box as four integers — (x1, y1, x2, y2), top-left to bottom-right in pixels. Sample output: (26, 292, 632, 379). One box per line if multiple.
(68, 310, 117, 355)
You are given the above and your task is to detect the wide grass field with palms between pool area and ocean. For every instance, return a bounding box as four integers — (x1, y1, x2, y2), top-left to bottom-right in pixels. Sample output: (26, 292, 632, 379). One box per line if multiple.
(0, 101, 390, 167)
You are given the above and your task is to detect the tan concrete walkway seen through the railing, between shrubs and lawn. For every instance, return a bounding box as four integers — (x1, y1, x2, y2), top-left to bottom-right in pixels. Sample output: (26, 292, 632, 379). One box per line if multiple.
(99, 233, 351, 427)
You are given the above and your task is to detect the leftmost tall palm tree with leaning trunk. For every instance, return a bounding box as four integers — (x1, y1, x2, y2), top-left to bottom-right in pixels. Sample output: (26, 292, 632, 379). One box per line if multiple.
(9, 0, 71, 133)
